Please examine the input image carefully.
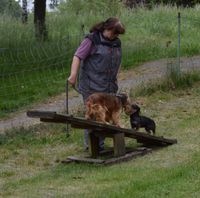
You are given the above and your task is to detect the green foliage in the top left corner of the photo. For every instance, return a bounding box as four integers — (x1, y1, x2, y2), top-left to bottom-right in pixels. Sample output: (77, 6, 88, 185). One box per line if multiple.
(0, 0, 22, 18)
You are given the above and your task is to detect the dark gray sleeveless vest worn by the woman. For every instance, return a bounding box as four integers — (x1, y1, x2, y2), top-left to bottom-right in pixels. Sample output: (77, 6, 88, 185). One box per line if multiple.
(79, 32, 121, 96)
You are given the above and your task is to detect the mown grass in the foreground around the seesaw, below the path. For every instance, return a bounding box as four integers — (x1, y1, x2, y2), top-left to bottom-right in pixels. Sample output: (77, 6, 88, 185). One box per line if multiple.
(0, 82, 200, 198)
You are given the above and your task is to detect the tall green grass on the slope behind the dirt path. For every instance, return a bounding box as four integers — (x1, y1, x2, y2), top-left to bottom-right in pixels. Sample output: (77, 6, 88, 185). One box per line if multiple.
(0, 6, 200, 117)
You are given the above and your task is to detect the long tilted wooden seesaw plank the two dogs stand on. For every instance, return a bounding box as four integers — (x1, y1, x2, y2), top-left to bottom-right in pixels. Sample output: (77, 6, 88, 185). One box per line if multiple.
(27, 111, 177, 146)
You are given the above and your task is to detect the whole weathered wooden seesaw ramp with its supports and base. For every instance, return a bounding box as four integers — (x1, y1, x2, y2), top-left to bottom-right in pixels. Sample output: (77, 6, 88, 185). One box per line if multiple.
(27, 111, 177, 164)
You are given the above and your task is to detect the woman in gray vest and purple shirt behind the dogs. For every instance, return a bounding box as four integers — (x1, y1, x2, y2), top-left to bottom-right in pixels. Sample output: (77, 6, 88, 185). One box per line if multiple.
(68, 17, 125, 149)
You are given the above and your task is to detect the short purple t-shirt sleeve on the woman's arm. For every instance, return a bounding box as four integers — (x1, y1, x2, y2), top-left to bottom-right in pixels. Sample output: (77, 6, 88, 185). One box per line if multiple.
(74, 38, 95, 60)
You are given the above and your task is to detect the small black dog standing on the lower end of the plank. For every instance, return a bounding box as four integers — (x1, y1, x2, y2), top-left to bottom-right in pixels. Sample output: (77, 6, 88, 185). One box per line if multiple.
(130, 104, 156, 134)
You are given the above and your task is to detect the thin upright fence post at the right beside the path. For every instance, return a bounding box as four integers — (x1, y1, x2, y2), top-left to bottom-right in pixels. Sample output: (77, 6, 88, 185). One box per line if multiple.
(176, 12, 181, 76)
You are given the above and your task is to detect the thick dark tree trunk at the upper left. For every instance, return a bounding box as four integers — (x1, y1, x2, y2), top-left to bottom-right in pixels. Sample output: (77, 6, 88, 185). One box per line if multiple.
(34, 0, 47, 41)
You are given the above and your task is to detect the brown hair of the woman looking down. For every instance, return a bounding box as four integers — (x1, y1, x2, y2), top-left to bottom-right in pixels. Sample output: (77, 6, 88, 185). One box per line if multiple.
(90, 17, 125, 34)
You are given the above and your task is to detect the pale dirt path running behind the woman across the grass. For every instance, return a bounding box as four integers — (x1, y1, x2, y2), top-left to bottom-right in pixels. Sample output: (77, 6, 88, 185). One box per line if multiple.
(0, 56, 200, 133)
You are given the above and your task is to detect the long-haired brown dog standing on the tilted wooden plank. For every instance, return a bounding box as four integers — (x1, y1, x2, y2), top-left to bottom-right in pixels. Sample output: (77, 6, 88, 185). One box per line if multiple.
(85, 93, 132, 127)
